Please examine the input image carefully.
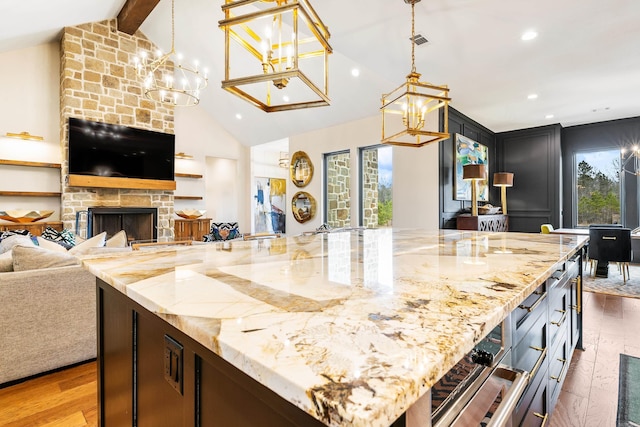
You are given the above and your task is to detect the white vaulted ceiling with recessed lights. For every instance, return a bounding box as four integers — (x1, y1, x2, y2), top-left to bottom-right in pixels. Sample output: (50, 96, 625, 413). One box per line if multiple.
(0, 0, 640, 145)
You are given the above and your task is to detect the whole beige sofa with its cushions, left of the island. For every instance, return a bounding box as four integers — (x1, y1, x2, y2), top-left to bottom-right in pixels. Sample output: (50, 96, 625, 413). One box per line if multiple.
(0, 233, 131, 387)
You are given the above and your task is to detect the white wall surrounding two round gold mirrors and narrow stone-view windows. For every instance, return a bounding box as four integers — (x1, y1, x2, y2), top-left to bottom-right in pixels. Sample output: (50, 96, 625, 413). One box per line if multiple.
(287, 113, 439, 235)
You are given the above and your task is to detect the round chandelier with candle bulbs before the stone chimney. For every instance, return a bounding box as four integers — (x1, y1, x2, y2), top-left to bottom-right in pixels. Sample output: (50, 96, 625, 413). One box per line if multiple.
(134, 0, 209, 106)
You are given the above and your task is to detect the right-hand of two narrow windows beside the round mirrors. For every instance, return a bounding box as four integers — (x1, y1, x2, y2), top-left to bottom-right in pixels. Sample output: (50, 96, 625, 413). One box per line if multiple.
(360, 145, 393, 228)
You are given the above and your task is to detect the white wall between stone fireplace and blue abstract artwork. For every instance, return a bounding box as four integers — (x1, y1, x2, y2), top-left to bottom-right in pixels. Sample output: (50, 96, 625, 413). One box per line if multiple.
(175, 106, 251, 232)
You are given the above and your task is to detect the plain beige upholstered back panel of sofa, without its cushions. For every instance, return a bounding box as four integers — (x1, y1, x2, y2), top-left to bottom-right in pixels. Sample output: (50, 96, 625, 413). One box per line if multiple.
(0, 265, 96, 385)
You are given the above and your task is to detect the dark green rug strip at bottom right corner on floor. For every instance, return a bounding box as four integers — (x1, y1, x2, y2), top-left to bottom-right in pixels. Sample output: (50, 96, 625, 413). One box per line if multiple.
(616, 353, 640, 427)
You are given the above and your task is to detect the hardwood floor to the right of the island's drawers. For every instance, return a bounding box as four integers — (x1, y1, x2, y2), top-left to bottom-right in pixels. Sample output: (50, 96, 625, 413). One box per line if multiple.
(549, 292, 640, 427)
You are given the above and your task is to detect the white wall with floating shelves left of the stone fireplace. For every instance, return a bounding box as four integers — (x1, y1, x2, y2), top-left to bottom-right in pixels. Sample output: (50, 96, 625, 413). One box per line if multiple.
(0, 43, 62, 222)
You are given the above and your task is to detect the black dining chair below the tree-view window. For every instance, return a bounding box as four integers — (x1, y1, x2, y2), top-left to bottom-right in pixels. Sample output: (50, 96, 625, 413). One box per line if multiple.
(588, 226, 631, 283)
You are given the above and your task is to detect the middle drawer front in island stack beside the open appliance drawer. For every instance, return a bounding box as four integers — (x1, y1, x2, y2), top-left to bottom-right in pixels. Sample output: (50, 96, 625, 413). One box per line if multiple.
(511, 316, 548, 378)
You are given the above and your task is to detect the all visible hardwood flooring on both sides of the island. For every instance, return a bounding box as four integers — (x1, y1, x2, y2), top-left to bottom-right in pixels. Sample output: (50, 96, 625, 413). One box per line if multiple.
(0, 292, 640, 427)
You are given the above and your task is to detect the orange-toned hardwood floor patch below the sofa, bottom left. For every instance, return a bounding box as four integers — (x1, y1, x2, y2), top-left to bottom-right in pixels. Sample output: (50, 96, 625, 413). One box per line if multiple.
(0, 362, 98, 427)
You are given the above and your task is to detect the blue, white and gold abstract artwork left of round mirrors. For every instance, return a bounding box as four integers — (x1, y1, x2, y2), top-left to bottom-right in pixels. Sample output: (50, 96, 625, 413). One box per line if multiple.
(253, 177, 287, 234)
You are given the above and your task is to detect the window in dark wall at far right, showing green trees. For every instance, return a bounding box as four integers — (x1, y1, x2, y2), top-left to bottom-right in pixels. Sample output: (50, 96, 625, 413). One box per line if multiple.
(575, 149, 621, 227)
